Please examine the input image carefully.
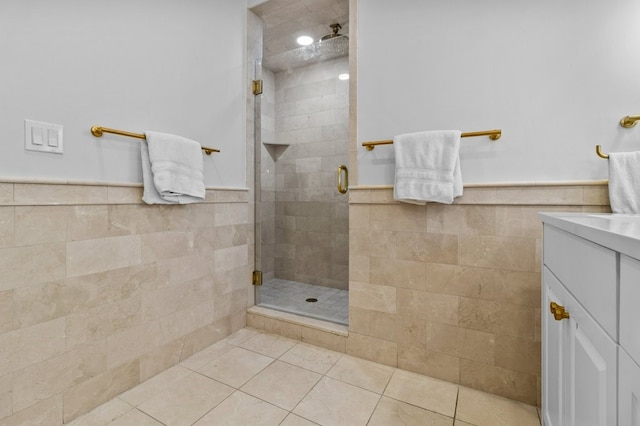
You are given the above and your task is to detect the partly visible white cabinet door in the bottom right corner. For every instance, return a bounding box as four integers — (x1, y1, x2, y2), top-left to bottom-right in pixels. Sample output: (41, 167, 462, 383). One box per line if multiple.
(618, 349, 640, 426)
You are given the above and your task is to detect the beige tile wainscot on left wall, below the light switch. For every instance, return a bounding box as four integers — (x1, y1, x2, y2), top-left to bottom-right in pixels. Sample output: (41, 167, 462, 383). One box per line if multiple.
(0, 182, 253, 425)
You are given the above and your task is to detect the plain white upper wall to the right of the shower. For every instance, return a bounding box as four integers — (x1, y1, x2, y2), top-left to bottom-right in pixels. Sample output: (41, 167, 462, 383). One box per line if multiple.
(358, 0, 640, 185)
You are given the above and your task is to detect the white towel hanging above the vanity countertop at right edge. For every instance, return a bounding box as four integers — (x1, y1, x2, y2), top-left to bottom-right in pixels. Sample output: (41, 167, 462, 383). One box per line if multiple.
(609, 151, 640, 214)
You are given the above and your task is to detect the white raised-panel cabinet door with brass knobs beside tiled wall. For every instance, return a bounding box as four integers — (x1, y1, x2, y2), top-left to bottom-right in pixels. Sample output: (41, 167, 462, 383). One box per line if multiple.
(543, 268, 618, 426)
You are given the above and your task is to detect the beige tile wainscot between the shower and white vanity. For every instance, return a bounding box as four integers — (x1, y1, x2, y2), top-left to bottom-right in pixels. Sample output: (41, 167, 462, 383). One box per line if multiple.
(346, 185, 609, 405)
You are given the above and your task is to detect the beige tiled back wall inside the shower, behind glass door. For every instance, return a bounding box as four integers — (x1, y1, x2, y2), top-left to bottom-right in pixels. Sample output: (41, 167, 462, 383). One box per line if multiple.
(275, 56, 349, 289)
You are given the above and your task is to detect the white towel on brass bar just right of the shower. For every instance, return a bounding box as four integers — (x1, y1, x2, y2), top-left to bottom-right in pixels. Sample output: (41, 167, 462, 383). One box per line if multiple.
(393, 130, 462, 204)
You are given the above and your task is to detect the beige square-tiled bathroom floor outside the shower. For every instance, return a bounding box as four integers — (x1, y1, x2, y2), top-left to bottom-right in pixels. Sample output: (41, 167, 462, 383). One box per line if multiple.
(70, 328, 540, 426)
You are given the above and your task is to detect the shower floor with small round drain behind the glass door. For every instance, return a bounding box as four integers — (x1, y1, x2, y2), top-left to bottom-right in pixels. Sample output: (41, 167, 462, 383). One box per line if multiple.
(258, 278, 349, 325)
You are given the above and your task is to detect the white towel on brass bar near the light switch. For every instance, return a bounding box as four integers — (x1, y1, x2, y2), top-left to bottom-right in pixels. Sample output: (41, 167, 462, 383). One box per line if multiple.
(140, 132, 205, 204)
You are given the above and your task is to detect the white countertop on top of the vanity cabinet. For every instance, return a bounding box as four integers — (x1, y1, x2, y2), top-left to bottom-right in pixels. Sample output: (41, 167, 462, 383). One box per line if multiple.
(540, 212, 640, 260)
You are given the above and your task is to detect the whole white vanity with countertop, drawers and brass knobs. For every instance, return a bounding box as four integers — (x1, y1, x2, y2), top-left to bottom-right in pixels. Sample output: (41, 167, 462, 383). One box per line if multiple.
(541, 213, 640, 426)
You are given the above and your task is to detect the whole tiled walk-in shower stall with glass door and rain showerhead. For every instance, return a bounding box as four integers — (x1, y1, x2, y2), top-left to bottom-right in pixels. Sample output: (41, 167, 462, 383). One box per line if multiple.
(251, 0, 349, 325)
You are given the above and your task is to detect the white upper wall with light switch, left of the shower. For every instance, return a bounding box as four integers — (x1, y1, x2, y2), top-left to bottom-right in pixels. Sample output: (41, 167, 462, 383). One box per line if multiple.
(0, 0, 246, 187)
